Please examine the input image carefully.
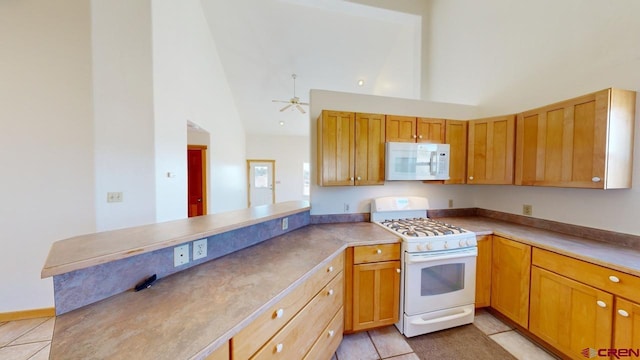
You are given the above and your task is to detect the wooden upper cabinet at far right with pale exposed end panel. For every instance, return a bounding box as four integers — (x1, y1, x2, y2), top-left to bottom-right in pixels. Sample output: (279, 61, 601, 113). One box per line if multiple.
(515, 89, 636, 189)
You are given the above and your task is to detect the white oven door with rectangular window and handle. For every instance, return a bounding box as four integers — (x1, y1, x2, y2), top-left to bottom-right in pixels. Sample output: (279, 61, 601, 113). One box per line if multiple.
(404, 247, 478, 316)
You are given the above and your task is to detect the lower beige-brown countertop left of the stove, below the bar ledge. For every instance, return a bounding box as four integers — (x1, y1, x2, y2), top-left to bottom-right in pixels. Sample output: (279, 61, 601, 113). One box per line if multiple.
(50, 223, 400, 359)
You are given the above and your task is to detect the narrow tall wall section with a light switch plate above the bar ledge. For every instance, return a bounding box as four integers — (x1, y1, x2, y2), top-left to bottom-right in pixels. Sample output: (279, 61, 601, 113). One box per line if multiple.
(91, 0, 156, 231)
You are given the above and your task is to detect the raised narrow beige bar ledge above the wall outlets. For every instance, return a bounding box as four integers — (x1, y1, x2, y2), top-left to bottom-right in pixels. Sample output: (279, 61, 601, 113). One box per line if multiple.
(41, 201, 310, 278)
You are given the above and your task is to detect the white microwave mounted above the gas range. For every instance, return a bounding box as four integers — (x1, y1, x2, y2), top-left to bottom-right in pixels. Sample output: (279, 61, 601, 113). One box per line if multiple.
(385, 142, 450, 180)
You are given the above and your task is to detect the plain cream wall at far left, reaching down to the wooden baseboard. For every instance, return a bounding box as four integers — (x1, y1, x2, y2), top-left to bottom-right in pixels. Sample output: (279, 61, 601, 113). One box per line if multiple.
(0, 0, 96, 313)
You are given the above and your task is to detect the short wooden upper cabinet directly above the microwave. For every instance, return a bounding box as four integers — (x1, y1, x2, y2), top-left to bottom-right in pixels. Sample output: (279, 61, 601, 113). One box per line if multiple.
(386, 115, 445, 144)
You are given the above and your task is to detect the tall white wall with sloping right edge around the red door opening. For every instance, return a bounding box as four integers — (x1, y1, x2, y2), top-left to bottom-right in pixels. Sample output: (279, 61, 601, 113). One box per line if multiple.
(152, 0, 247, 221)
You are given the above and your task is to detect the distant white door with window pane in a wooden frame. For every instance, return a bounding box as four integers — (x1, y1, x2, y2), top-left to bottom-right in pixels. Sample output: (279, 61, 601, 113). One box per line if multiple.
(247, 160, 276, 207)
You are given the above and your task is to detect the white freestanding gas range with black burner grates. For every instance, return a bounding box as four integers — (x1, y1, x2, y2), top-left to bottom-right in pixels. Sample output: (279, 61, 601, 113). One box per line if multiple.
(371, 196, 478, 337)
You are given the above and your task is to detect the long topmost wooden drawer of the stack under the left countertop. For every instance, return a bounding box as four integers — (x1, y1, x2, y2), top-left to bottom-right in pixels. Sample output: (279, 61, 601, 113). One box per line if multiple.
(231, 254, 344, 359)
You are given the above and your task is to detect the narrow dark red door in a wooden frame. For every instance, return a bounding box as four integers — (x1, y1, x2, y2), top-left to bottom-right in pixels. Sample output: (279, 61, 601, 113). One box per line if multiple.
(187, 145, 207, 217)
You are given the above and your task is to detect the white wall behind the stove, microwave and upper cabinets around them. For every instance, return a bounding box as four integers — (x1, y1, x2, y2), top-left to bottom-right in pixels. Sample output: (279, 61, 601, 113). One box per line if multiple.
(310, 90, 478, 215)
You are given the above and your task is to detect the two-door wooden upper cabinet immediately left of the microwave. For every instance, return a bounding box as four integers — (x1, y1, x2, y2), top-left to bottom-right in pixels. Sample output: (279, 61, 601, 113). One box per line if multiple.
(318, 110, 385, 186)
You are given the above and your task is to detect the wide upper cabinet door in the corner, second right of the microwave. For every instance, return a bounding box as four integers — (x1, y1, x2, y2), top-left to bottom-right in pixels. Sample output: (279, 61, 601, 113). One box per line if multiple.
(467, 115, 515, 184)
